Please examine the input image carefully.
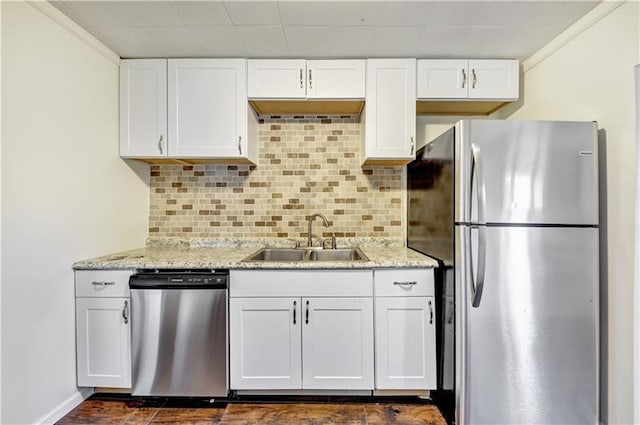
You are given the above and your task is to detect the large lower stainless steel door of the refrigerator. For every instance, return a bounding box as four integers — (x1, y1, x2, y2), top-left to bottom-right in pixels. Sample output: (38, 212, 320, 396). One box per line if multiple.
(456, 227, 599, 425)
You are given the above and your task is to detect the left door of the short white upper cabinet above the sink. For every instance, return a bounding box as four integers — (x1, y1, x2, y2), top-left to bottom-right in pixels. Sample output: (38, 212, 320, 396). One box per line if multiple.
(247, 59, 306, 99)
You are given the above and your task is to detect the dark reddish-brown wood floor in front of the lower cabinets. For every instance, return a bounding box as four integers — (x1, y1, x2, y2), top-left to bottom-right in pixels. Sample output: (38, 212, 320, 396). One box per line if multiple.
(58, 395, 446, 425)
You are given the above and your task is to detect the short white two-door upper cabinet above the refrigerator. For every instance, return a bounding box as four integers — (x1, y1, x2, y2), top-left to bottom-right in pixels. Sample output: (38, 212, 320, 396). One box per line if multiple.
(417, 59, 519, 100)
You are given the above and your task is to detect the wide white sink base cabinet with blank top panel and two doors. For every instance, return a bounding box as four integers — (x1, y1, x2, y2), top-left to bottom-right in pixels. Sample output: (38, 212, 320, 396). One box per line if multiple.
(229, 270, 374, 390)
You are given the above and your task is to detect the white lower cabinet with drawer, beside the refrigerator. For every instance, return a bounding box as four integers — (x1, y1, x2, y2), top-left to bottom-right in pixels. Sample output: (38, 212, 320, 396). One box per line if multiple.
(374, 269, 437, 390)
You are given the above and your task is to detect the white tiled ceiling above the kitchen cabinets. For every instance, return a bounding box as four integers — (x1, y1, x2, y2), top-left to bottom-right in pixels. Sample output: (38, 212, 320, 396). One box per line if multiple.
(51, 0, 600, 60)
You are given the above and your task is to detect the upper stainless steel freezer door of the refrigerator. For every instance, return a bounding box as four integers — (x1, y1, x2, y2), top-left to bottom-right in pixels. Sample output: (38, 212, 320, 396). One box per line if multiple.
(456, 120, 598, 225)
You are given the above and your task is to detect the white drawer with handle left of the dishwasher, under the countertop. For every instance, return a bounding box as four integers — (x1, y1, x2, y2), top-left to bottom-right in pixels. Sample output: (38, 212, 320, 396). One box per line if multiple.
(76, 270, 133, 297)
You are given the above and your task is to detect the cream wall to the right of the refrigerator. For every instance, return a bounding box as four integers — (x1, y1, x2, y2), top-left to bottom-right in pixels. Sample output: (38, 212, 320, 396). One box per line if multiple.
(501, 1, 640, 424)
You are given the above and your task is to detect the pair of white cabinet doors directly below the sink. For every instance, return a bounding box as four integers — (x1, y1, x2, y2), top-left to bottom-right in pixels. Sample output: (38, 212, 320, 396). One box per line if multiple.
(230, 298, 374, 390)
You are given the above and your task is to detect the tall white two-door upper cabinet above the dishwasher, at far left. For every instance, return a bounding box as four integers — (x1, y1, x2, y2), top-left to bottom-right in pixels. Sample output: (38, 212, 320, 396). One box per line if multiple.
(120, 59, 258, 163)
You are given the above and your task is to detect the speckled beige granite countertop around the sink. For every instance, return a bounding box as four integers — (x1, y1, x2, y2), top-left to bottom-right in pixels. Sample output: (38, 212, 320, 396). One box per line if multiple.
(73, 238, 438, 270)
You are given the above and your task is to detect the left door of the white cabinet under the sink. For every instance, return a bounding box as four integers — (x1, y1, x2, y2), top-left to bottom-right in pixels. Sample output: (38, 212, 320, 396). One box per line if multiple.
(229, 298, 302, 390)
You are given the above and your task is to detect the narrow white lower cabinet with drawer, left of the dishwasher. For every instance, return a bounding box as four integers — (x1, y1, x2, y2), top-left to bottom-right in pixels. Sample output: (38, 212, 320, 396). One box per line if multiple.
(76, 270, 131, 388)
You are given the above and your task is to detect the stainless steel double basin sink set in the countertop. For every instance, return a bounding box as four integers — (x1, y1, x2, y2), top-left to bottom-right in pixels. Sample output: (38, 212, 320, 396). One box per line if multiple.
(242, 248, 369, 263)
